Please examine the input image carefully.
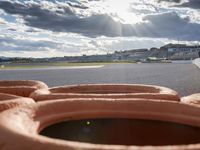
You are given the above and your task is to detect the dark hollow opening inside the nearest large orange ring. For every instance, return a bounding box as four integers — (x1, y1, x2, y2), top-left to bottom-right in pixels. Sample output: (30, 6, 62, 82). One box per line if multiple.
(40, 118, 200, 146)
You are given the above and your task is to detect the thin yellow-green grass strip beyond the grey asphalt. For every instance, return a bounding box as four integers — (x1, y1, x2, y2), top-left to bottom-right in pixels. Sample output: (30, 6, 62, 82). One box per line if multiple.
(0, 62, 135, 70)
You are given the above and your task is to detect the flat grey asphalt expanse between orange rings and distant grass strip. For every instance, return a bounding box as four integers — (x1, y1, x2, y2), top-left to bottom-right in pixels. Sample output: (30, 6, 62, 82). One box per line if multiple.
(0, 63, 200, 96)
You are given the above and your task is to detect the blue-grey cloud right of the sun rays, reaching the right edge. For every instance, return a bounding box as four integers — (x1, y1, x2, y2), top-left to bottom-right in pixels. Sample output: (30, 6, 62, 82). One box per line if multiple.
(141, 12, 200, 41)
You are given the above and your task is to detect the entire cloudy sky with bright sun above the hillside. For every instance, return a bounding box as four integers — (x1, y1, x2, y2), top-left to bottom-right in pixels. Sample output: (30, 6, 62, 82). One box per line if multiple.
(0, 0, 200, 58)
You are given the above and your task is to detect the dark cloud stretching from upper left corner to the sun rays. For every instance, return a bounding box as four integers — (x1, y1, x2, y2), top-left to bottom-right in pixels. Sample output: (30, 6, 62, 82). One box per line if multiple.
(0, 1, 138, 37)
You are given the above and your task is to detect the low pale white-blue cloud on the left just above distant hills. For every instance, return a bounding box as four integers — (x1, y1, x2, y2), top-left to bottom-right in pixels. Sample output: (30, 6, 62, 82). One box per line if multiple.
(0, 34, 99, 57)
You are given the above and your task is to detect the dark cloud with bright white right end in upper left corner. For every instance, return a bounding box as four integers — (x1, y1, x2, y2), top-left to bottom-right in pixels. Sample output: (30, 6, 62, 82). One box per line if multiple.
(0, 1, 77, 16)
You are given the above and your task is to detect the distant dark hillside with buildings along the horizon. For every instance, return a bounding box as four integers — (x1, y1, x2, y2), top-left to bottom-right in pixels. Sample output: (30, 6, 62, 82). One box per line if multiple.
(0, 43, 200, 65)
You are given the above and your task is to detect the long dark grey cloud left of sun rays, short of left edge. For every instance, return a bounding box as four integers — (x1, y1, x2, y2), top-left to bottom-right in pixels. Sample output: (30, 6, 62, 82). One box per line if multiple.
(26, 12, 138, 37)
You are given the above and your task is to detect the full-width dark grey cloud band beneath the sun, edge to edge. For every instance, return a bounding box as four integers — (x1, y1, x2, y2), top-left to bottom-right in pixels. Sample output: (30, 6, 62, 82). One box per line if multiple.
(0, 1, 200, 40)
